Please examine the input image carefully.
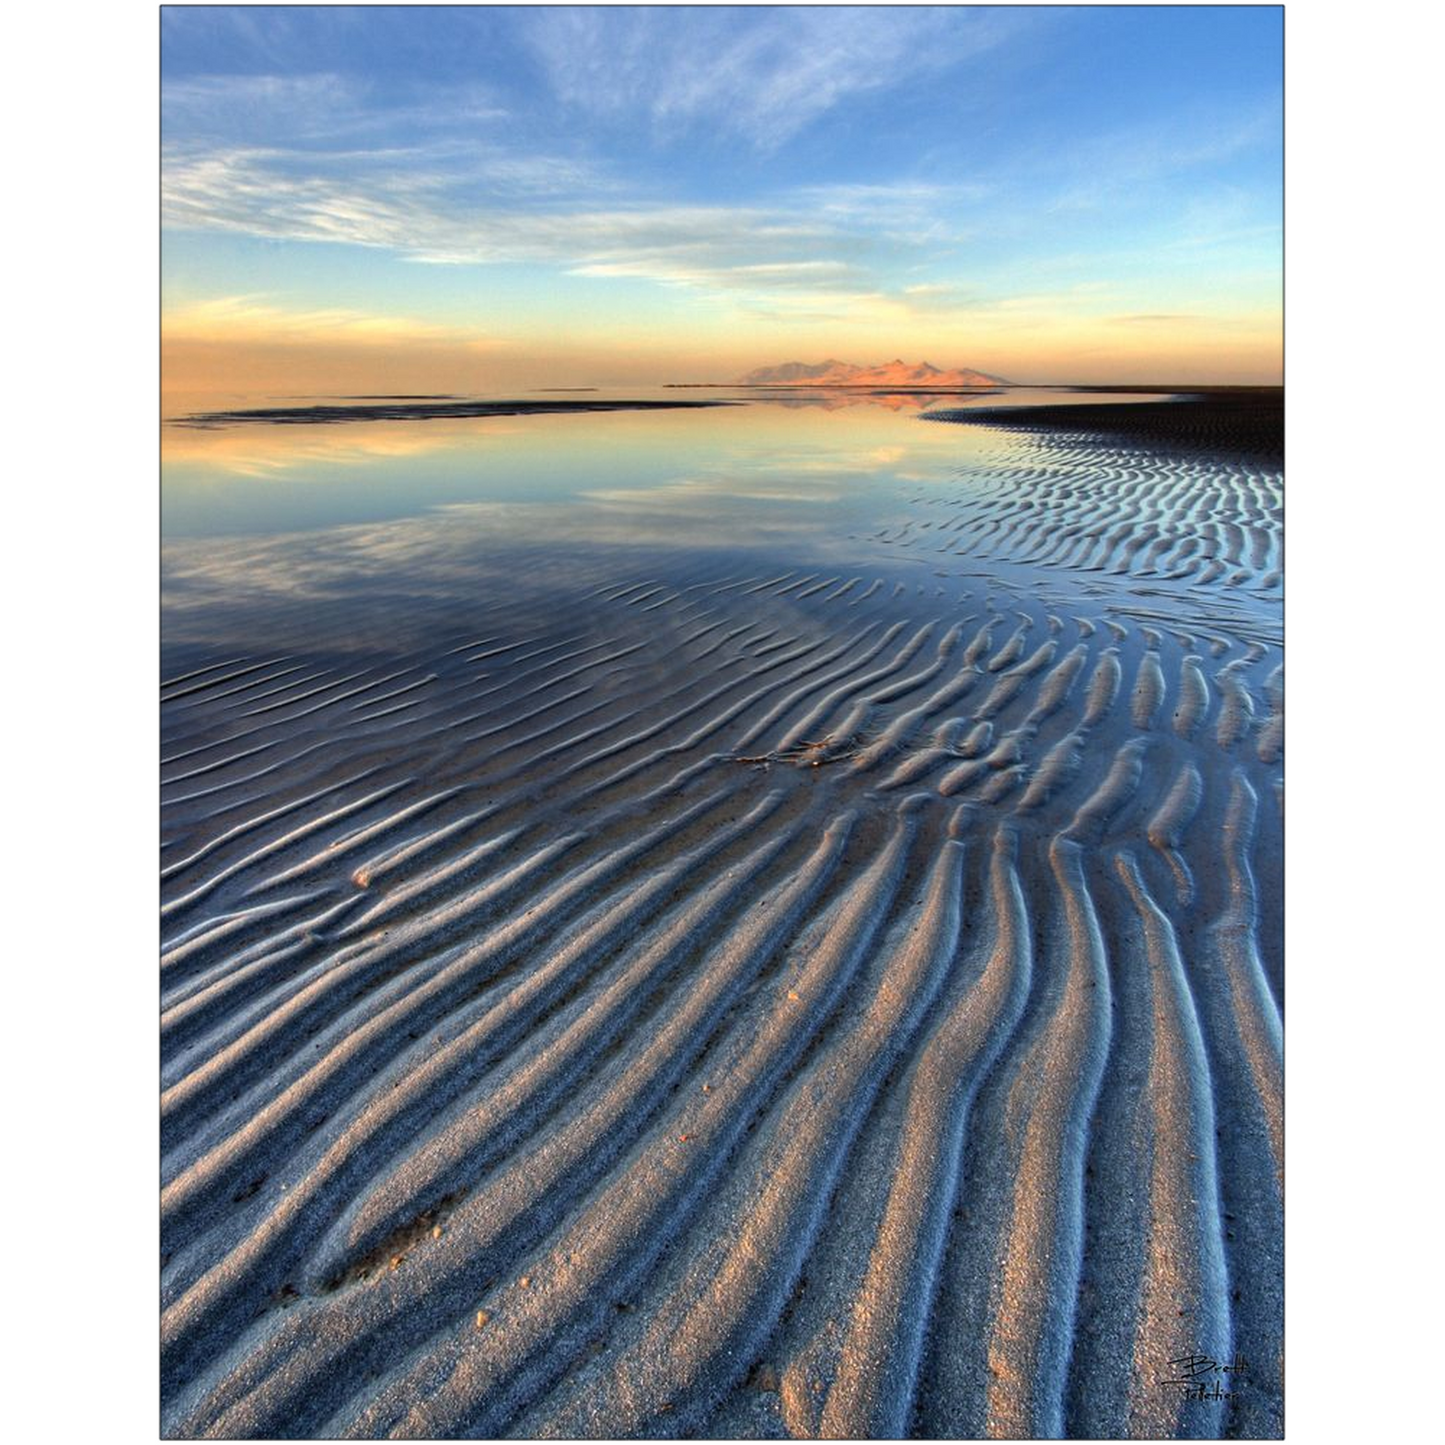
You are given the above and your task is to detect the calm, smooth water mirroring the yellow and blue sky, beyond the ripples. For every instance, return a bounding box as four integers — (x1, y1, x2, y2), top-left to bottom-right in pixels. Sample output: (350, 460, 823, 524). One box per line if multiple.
(162, 390, 1115, 657)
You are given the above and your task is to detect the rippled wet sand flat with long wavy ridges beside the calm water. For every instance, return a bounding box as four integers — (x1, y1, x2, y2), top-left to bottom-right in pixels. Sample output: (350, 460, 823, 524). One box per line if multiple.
(162, 399, 1283, 1438)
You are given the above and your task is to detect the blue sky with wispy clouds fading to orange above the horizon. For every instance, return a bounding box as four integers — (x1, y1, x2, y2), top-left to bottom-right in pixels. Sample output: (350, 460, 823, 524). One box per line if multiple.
(160, 6, 1283, 393)
